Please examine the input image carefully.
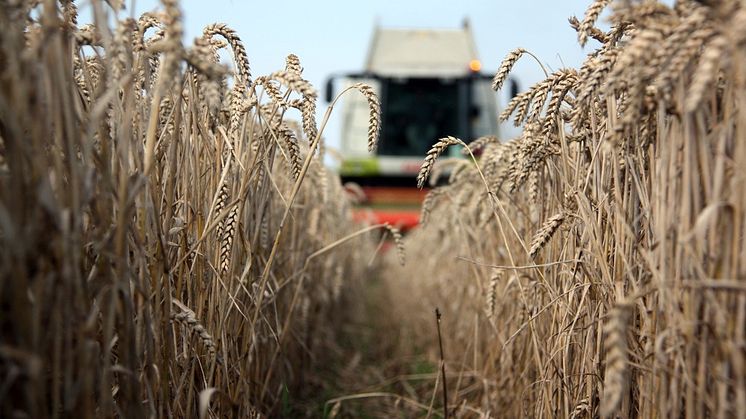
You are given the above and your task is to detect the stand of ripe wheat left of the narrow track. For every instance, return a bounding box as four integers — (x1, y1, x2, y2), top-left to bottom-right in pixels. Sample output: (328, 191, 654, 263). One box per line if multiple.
(0, 1, 384, 418)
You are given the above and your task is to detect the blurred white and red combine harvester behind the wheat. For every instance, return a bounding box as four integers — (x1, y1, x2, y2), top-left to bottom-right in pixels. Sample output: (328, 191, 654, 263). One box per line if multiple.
(325, 21, 506, 230)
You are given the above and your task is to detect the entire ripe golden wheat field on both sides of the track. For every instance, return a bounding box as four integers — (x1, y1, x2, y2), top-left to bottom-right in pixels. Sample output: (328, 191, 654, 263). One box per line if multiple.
(0, 0, 746, 419)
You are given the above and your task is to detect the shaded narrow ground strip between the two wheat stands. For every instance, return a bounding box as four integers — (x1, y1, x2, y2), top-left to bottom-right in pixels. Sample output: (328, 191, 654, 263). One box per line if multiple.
(293, 270, 442, 418)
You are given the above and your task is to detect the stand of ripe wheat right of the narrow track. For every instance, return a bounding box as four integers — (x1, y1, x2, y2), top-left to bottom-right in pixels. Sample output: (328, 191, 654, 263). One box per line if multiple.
(380, 1, 746, 418)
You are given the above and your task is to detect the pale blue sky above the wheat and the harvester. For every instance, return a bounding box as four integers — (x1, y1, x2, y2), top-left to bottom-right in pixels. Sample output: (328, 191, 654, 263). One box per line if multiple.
(87, 0, 612, 151)
